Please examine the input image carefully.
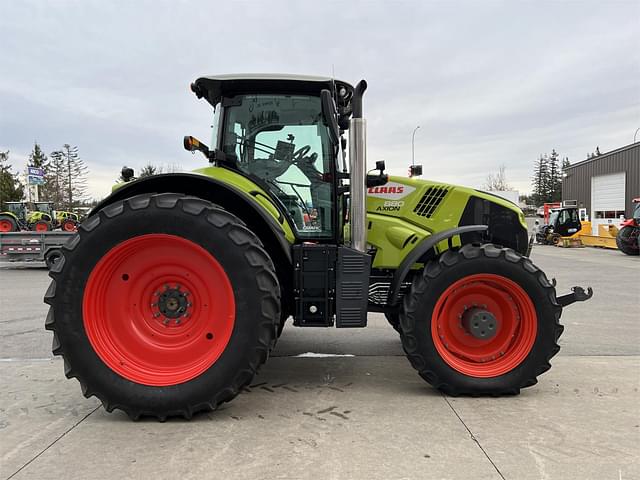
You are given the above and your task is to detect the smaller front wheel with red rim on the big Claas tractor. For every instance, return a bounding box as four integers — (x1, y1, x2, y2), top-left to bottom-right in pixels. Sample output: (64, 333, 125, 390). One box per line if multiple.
(401, 244, 563, 395)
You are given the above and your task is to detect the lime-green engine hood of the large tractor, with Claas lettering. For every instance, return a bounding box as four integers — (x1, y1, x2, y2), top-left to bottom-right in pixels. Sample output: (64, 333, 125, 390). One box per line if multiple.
(367, 177, 526, 269)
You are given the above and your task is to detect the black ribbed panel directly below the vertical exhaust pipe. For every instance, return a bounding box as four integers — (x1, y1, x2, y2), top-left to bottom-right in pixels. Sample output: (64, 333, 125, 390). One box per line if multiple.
(336, 247, 371, 328)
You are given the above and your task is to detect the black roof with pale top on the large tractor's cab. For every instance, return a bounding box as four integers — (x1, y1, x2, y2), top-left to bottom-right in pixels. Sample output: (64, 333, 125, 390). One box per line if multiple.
(191, 73, 353, 106)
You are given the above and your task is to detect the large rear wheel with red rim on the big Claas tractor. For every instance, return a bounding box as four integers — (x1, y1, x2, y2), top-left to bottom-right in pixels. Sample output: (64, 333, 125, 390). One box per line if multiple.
(45, 193, 280, 421)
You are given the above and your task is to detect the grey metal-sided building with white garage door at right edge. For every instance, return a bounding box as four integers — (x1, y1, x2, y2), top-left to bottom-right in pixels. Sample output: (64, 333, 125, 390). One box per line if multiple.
(562, 142, 640, 235)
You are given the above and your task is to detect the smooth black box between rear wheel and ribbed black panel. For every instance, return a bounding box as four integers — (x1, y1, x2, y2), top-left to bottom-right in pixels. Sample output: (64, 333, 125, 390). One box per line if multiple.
(293, 244, 336, 327)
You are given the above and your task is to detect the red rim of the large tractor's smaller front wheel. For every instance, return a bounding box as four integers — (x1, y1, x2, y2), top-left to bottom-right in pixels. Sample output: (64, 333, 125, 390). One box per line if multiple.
(431, 274, 538, 378)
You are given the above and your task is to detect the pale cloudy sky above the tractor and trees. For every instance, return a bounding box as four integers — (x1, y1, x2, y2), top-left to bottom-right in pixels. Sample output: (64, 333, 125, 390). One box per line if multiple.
(0, 0, 640, 199)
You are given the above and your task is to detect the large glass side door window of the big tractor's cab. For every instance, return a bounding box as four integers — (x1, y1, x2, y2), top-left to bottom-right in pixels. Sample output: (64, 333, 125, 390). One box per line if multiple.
(221, 95, 333, 237)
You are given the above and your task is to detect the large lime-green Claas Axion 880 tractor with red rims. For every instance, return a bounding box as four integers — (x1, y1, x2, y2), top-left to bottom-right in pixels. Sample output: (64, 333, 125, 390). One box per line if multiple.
(45, 75, 592, 420)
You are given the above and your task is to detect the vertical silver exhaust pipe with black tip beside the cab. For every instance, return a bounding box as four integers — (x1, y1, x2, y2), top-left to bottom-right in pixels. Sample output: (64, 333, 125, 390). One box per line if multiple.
(349, 80, 367, 252)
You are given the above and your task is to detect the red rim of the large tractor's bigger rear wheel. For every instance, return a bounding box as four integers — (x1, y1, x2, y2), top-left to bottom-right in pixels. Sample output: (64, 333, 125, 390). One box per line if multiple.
(82, 234, 235, 386)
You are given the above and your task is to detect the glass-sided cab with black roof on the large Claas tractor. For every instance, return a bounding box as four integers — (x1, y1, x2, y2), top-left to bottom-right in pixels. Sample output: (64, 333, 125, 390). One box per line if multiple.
(185, 75, 360, 241)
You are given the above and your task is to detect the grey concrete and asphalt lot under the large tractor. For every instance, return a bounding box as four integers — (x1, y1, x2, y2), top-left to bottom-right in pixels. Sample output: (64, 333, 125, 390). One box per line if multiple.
(0, 247, 640, 479)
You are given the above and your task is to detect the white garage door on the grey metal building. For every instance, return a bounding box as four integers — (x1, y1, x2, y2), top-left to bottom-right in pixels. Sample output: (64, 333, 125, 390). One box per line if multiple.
(591, 172, 626, 235)
